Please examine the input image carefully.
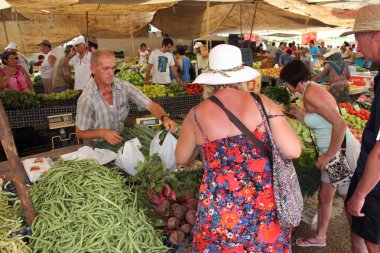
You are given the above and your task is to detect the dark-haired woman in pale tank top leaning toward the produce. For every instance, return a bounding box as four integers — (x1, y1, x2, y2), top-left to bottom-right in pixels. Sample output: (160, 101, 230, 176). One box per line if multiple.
(280, 60, 365, 251)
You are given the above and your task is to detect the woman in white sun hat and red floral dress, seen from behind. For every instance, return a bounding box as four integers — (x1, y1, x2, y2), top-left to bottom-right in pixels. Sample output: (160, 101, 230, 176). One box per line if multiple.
(176, 45, 301, 253)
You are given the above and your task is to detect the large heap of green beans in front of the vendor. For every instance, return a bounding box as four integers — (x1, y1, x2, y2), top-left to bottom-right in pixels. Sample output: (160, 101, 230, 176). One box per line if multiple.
(30, 159, 169, 253)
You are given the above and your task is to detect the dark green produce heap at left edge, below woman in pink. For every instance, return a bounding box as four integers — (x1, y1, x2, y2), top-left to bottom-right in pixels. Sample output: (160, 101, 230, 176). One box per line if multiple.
(0, 90, 41, 109)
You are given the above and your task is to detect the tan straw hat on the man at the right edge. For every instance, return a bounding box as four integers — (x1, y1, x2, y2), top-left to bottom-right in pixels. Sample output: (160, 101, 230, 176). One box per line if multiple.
(340, 4, 380, 37)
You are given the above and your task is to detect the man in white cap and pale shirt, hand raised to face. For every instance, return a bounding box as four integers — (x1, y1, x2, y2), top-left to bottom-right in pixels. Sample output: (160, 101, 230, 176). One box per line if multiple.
(63, 35, 91, 90)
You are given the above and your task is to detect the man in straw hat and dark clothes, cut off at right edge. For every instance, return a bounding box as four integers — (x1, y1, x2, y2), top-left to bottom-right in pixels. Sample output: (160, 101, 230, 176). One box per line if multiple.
(342, 4, 380, 253)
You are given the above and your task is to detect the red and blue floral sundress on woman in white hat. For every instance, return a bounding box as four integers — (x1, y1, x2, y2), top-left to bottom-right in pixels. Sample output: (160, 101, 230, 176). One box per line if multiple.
(193, 110, 291, 253)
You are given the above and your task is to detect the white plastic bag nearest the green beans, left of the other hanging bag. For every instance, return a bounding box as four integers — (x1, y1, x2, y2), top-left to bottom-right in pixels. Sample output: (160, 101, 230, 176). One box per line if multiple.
(116, 138, 144, 176)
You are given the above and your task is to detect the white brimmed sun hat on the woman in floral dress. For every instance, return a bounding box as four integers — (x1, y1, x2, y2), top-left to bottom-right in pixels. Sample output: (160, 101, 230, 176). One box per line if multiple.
(194, 44, 260, 85)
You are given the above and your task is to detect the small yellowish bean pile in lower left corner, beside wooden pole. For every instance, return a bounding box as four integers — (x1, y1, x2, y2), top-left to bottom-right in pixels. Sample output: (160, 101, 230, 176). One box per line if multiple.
(0, 187, 32, 253)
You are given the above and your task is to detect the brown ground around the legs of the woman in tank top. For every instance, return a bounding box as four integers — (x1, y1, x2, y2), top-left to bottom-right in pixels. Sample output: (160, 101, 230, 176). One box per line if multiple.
(292, 196, 351, 253)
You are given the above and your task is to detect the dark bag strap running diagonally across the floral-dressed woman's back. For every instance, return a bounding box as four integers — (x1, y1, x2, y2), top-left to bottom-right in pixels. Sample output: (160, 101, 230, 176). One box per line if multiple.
(209, 96, 271, 158)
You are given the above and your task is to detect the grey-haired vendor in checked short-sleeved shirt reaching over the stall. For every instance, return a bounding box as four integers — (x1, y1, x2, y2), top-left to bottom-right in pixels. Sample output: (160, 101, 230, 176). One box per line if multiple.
(76, 50, 177, 145)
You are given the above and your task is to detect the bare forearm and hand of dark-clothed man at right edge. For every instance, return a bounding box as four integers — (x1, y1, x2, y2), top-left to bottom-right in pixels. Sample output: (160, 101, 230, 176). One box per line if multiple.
(354, 141, 380, 198)
